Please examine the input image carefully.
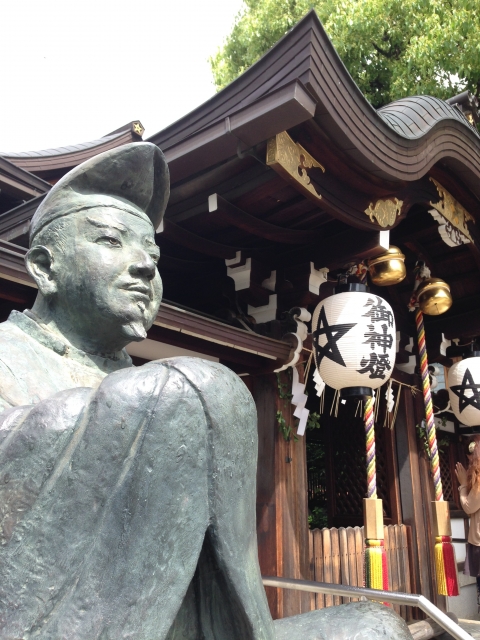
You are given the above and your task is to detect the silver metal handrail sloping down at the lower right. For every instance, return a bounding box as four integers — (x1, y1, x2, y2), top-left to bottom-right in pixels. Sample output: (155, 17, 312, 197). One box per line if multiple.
(262, 576, 473, 640)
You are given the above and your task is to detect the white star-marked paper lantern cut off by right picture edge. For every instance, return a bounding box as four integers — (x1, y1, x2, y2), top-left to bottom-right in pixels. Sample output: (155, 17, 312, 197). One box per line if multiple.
(448, 356, 480, 427)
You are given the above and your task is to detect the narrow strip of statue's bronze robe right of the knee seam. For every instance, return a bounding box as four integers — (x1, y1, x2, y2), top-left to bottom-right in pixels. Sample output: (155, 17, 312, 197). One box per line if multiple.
(159, 358, 275, 640)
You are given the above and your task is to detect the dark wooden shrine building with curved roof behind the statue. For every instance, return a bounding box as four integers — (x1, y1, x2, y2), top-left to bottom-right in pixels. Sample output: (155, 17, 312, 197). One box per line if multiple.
(0, 11, 480, 621)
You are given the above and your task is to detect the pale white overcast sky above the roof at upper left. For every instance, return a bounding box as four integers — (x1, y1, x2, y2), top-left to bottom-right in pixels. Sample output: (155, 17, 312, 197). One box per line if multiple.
(0, 0, 242, 152)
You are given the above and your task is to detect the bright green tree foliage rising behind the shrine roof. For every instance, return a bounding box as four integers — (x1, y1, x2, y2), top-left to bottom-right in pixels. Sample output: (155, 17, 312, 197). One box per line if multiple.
(210, 0, 480, 108)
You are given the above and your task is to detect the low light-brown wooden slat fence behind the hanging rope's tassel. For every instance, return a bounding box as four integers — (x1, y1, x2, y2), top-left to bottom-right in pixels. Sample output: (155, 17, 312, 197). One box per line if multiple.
(310, 525, 411, 620)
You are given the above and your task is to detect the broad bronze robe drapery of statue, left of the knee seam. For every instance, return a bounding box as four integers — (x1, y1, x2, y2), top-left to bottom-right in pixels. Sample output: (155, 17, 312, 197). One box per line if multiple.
(0, 363, 212, 640)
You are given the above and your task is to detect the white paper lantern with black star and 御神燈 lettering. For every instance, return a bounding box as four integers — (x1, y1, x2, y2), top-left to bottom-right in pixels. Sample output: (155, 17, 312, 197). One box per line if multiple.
(312, 284, 396, 396)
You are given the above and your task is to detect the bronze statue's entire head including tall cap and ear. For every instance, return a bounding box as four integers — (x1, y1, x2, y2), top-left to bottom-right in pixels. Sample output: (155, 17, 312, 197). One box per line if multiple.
(26, 143, 169, 353)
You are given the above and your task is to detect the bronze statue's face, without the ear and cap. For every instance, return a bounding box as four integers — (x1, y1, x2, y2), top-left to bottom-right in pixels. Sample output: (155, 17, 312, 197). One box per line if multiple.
(52, 207, 162, 351)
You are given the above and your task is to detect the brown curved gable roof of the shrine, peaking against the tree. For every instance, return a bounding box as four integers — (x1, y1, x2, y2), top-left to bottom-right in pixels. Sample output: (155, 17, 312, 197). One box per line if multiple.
(150, 10, 480, 202)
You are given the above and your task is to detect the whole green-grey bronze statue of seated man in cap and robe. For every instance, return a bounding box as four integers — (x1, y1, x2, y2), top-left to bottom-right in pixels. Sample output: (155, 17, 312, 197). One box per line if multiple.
(0, 143, 408, 640)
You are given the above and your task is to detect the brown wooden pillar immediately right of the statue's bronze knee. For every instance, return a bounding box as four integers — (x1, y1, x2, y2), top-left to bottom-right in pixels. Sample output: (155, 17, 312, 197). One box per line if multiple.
(249, 373, 311, 618)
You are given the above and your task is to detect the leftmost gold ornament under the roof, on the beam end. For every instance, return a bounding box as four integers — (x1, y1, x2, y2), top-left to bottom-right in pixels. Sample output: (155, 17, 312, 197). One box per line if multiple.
(267, 131, 325, 200)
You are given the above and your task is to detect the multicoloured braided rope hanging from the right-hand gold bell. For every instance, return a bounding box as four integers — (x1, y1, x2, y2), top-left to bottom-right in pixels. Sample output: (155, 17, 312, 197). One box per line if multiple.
(415, 309, 443, 500)
